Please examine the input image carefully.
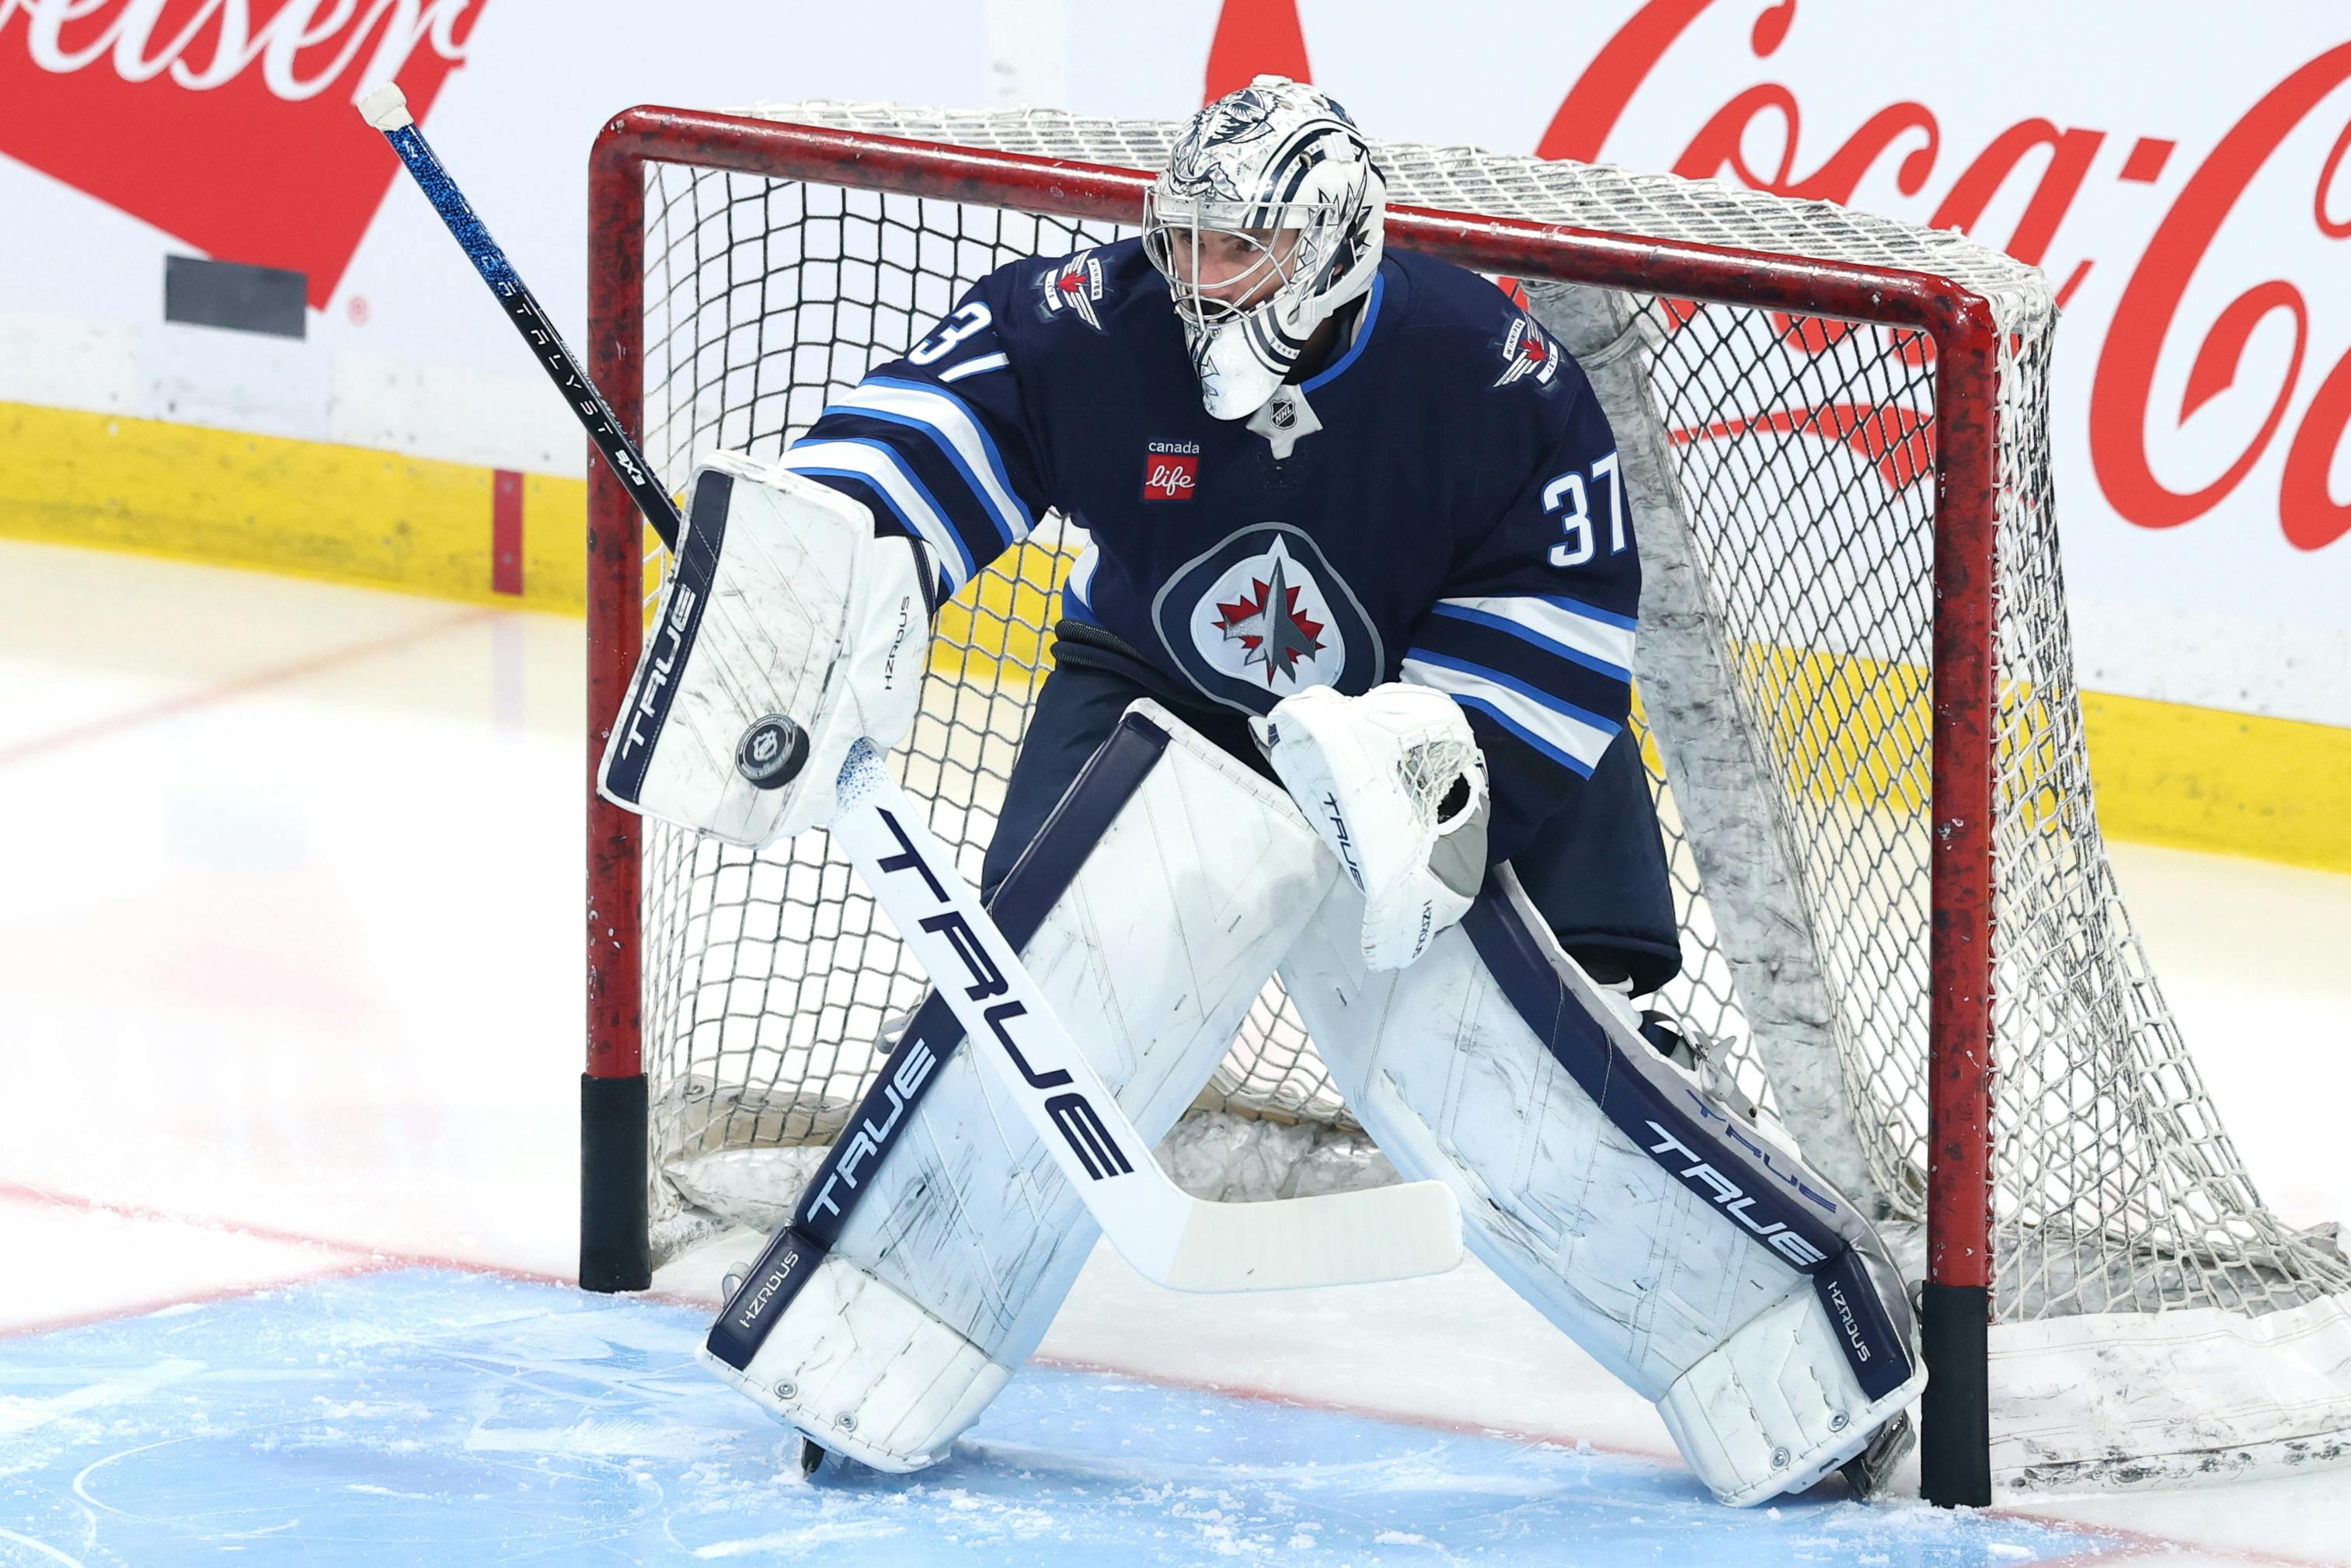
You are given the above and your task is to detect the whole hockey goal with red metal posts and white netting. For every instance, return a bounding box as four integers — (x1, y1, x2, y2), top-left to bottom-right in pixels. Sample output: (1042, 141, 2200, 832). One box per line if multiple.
(580, 103, 2351, 1502)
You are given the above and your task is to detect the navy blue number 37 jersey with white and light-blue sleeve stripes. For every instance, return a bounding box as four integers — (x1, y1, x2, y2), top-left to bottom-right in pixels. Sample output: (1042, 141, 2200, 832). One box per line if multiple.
(785, 240, 1641, 860)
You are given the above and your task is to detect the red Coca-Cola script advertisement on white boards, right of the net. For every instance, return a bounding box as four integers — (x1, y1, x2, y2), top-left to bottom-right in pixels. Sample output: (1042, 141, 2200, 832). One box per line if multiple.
(1535, 0, 2351, 724)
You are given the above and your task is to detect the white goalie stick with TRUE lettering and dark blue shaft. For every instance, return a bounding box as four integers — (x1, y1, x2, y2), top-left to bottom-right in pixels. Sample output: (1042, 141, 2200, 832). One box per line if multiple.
(357, 82, 1462, 1291)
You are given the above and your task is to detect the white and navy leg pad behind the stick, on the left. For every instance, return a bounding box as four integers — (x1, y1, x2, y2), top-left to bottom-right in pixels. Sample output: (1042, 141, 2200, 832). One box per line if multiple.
(705, 703, 1336, 1469)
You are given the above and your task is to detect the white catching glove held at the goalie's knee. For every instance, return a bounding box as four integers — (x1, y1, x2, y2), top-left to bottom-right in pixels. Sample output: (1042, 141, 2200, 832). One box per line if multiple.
(1251, 681, 1488, 969)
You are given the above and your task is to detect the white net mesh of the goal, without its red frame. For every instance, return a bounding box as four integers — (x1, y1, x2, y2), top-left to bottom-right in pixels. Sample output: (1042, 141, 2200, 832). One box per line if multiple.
(615, 103, 2351, 1363)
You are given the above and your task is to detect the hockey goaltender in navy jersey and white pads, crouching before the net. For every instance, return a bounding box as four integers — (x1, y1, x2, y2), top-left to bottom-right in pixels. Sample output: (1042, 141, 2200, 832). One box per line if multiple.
(607, 78, 1925, 1504)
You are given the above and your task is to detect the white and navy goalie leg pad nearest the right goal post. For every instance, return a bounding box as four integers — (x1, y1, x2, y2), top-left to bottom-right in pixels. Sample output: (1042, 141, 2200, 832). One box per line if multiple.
(1281, 867, 1925, 1504)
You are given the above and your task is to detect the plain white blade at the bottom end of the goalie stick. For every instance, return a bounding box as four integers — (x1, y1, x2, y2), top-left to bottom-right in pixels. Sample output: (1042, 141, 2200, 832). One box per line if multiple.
(1157, 1183, 1462, 1291)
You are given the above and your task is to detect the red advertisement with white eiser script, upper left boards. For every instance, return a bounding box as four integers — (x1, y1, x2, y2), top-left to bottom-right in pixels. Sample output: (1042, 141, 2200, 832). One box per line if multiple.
(0, 0, 486, 308)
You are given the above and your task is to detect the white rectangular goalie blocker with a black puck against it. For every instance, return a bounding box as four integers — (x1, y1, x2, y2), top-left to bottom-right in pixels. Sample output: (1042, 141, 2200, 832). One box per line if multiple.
(597, 451, 931, 848)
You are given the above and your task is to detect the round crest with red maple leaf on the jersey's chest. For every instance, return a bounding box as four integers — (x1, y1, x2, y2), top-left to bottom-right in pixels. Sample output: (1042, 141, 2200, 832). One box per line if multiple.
(1152, 522, 1384, 713)
